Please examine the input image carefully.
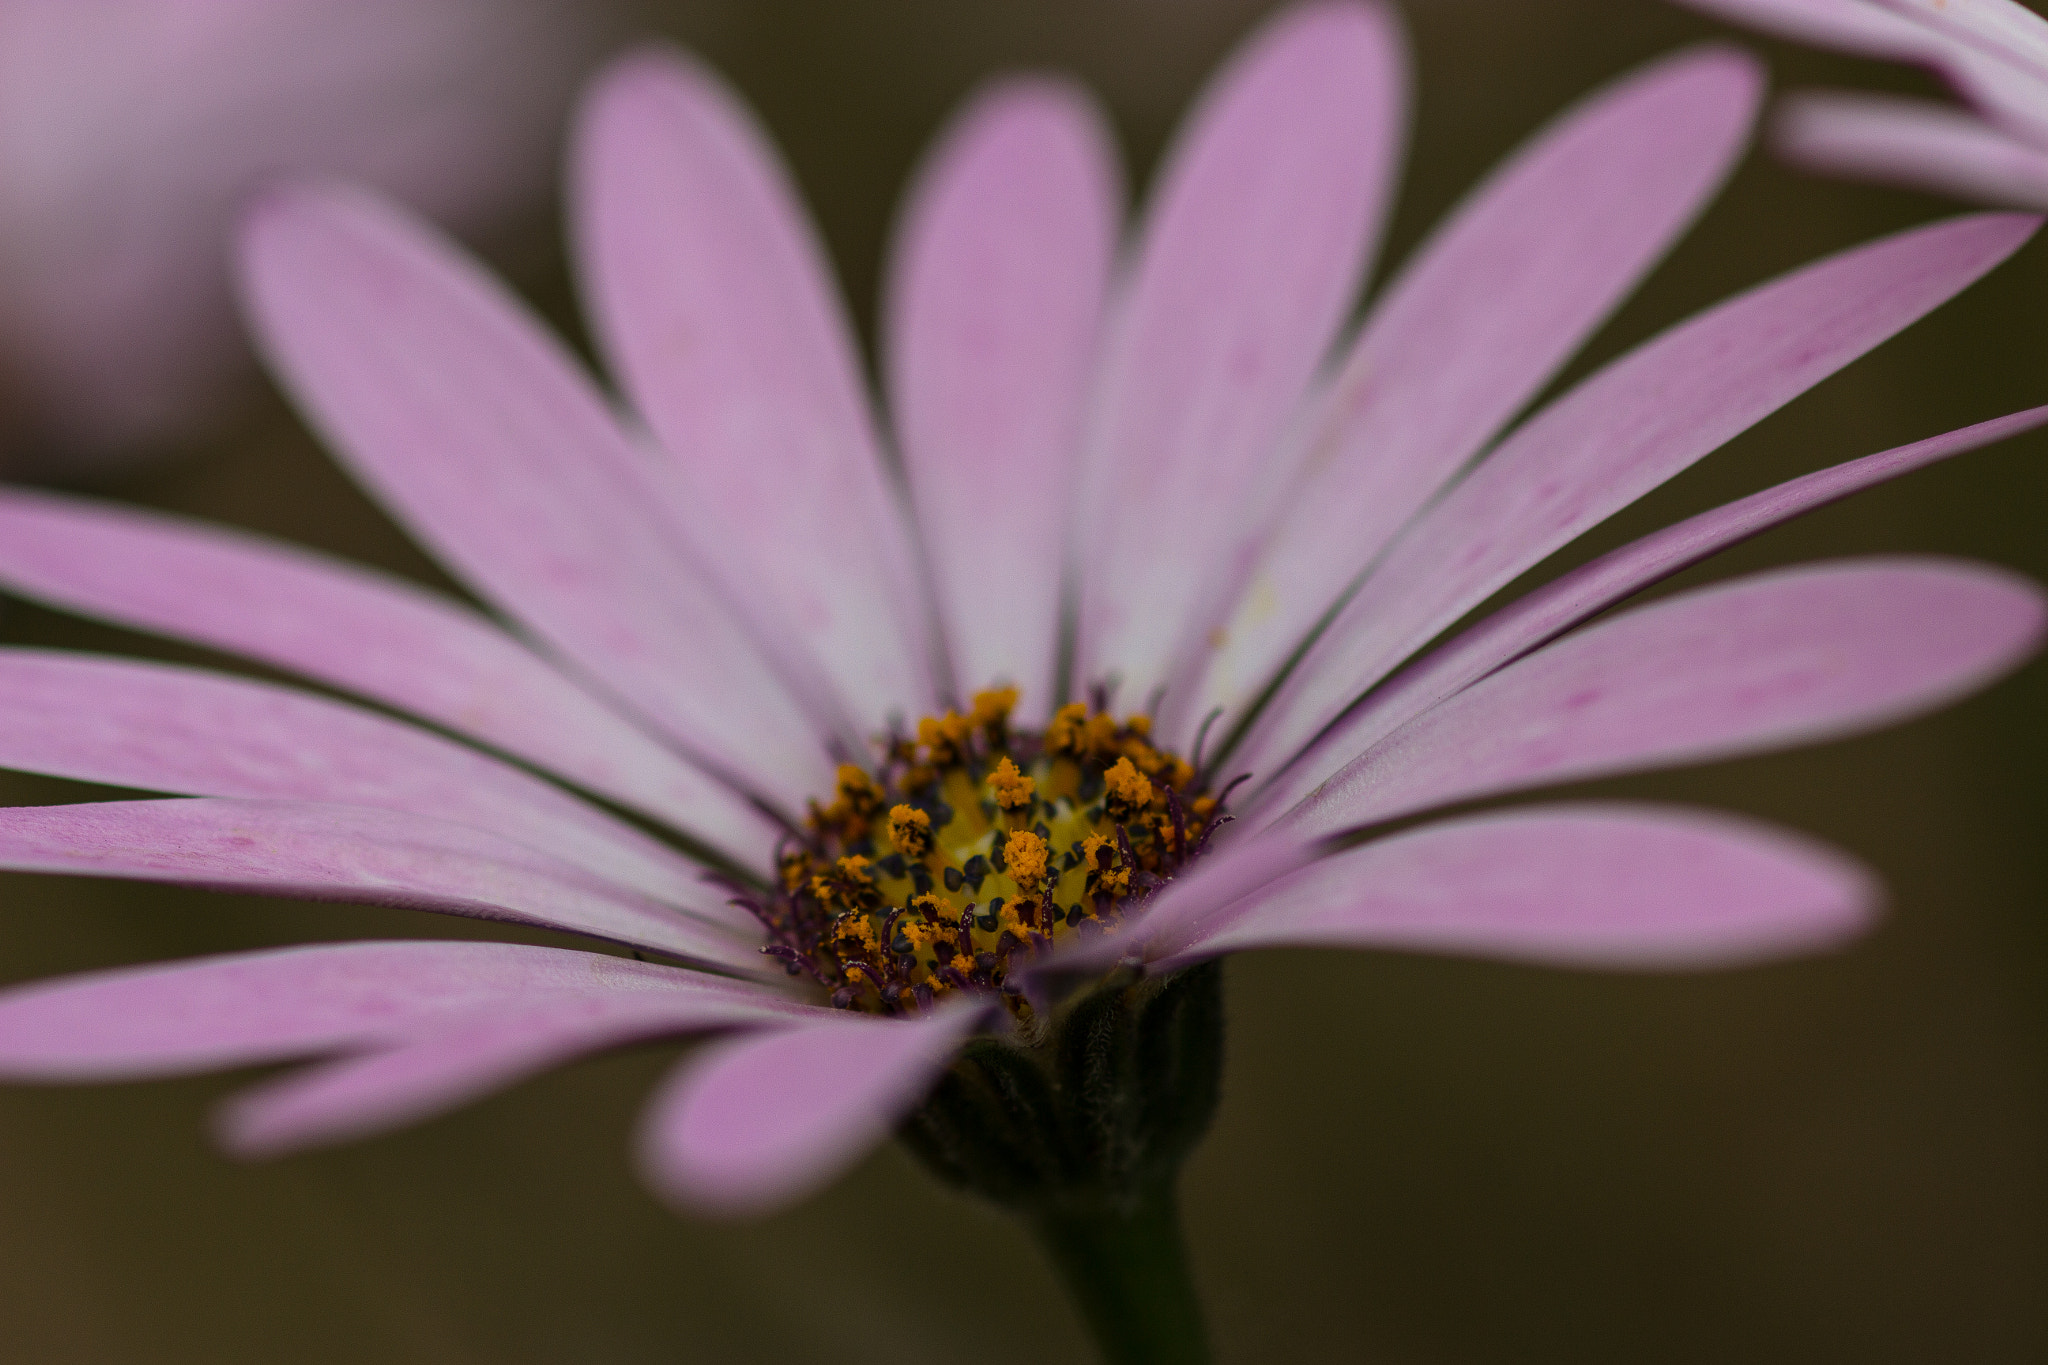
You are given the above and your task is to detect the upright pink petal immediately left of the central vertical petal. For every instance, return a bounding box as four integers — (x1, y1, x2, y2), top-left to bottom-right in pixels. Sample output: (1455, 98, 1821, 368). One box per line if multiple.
(571, 51, 934, 739)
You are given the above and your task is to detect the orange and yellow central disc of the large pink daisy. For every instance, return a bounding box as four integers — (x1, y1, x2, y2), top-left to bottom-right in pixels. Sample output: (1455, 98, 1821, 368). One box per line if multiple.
(748, 688, 1219, 1015)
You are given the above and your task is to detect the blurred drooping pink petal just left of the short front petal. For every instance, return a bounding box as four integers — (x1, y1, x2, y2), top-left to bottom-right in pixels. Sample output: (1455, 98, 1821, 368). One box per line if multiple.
(217, 976, 811, 1156)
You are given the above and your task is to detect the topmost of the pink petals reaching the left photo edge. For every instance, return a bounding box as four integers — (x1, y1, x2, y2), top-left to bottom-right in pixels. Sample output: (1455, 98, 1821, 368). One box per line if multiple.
(0, 489, 778, 866)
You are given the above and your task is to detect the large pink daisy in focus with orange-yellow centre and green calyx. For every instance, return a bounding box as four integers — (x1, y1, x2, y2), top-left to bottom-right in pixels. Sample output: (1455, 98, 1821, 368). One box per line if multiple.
(0, 2, 2048, 1353)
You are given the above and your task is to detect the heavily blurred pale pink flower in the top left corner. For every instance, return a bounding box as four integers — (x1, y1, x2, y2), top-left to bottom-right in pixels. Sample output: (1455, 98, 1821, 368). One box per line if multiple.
(0, 0, 604, 471)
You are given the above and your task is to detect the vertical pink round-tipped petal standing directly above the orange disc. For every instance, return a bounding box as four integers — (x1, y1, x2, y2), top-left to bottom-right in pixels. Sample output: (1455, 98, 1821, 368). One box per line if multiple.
(885, 80, 1118, 720)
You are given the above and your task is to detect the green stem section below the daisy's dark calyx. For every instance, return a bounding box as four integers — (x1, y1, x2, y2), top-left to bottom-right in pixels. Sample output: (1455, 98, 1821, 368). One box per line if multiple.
(1030, 1179, 1210, 1365)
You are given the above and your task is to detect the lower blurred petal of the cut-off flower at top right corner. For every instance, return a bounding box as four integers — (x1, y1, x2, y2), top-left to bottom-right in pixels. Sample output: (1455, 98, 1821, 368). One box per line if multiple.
(1776, 94, 2048, 209)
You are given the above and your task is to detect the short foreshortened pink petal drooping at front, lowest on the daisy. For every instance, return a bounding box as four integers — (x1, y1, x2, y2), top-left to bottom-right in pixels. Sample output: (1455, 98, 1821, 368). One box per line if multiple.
(641, 999, 991, 1216)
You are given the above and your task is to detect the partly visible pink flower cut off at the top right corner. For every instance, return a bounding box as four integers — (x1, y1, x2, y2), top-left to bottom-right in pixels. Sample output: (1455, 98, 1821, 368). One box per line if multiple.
(1681, 0, 2048, 209)
